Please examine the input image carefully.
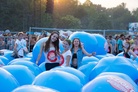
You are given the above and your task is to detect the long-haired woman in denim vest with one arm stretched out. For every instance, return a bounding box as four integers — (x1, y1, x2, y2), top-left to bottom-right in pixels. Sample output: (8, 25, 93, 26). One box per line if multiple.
(71, 38, 96, 69)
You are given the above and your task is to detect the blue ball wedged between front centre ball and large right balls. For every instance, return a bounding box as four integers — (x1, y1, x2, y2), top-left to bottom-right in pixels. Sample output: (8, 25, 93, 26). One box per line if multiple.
(78, 62, 98, 82)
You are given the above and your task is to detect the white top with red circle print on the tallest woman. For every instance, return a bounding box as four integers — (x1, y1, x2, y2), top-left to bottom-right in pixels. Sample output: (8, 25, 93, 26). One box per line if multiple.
(44, 47, 59, 63)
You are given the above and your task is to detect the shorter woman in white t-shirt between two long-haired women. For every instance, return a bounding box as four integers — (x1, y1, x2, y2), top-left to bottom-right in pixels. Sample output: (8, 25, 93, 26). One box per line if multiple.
(62, 39, 72, 66)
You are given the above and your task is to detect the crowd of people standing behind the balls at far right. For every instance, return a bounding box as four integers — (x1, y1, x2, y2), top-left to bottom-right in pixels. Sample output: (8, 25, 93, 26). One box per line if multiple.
(105, 34, 138, 60)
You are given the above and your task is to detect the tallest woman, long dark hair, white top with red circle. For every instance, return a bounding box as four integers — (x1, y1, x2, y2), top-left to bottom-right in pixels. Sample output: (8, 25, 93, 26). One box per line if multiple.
(36, 31, 60, 70)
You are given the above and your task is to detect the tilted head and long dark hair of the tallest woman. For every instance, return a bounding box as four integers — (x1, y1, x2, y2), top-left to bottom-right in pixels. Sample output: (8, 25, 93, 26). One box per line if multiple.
(45, 31, 59, 52)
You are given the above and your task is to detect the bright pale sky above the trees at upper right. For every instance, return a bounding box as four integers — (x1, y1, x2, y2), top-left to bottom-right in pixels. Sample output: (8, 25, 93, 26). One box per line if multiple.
(80, 0, 138, 11)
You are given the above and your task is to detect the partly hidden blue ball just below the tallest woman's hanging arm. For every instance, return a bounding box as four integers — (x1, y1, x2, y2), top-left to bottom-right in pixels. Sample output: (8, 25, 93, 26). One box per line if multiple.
(10, 61, 42, 76)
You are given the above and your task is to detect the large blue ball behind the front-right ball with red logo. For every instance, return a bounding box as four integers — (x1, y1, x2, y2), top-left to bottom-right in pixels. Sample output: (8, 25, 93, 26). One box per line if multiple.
(90, 57, 138, 81)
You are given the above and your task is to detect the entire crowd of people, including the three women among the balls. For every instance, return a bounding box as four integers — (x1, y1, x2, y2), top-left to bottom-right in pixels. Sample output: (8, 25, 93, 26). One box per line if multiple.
(0, 31, 138, 70)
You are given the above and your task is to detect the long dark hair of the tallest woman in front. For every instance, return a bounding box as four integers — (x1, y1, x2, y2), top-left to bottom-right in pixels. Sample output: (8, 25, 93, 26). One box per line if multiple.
(44, 31, 59, 55)
